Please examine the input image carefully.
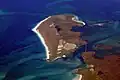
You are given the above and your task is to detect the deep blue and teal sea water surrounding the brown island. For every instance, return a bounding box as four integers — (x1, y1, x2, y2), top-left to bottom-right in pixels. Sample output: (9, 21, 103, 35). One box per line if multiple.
(0, 0, 120, 80)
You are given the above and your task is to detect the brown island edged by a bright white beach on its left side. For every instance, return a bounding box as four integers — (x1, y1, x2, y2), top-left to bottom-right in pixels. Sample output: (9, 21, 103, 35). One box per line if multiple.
(32, 14, 86, 61)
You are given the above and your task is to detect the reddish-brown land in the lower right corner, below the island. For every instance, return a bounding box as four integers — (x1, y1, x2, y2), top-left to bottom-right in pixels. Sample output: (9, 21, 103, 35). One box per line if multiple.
(76, 52, 120, 80)
